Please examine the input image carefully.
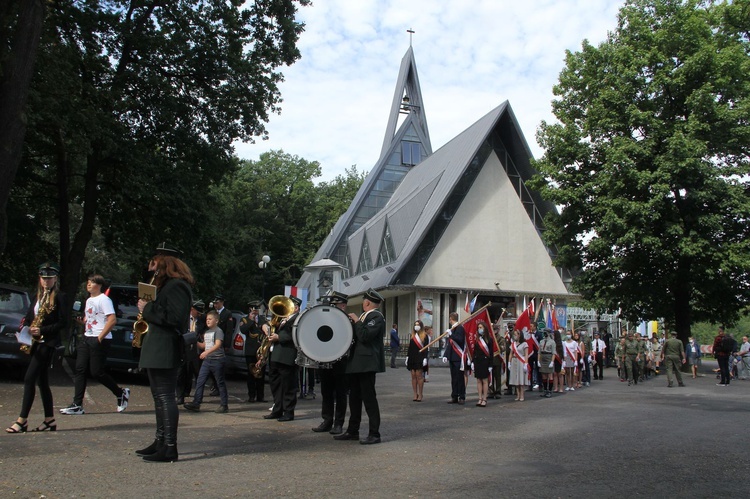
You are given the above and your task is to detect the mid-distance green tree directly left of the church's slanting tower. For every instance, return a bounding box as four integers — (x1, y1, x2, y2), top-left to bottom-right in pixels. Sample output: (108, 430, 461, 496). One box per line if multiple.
(210, 150, 364, 306)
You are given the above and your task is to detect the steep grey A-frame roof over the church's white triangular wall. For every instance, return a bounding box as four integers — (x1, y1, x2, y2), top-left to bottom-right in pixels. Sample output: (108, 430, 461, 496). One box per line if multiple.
(342, 102, 559, 295)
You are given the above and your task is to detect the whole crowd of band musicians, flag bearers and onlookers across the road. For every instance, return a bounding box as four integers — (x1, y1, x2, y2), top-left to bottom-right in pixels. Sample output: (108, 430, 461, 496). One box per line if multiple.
(6, 254, 750, 462)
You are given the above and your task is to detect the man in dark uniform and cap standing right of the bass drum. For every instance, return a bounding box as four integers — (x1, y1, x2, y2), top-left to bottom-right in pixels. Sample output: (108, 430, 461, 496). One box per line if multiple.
(333, 288, 385, 445)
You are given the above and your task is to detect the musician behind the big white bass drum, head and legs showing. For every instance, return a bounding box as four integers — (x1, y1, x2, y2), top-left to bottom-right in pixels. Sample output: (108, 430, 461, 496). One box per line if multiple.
(312, 291, 354, 435)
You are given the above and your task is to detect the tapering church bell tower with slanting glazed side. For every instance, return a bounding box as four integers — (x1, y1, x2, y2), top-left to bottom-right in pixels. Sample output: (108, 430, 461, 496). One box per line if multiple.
(297, 47, 432, 287)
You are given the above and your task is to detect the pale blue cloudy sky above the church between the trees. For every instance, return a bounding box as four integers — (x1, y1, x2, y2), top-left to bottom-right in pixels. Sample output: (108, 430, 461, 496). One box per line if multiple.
(235, 0, 624, 181)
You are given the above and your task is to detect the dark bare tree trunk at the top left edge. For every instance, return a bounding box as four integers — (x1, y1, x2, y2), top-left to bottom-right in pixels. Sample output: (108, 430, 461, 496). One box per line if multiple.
(0, 0, 45, 253)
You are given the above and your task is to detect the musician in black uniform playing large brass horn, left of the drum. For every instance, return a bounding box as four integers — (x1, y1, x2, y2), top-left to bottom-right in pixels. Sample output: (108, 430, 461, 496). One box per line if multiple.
(263, 296, 302, 423)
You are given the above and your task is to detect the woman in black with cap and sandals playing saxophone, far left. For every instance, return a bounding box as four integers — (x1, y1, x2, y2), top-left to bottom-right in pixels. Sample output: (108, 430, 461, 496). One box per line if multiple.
(5, 263, 68, 433)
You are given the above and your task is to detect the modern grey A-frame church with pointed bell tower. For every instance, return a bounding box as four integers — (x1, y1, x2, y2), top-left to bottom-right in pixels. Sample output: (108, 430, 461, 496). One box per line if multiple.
(297, 47, 575, 333)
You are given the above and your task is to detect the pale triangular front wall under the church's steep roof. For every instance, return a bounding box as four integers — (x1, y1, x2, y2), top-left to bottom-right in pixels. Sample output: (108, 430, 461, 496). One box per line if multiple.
(415, 152, 567, 295)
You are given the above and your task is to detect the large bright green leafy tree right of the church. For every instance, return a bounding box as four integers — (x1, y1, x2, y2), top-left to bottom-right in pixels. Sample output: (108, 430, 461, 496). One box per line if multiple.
(536, 0, 750, 340)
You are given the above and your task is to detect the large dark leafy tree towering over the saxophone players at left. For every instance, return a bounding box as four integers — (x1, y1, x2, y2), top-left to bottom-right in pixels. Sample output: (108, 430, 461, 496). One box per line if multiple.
(2, 0, 309, 300)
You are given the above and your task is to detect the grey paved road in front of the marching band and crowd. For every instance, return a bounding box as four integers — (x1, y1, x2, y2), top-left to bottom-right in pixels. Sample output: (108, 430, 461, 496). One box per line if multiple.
(0, 362, 750, 498)
